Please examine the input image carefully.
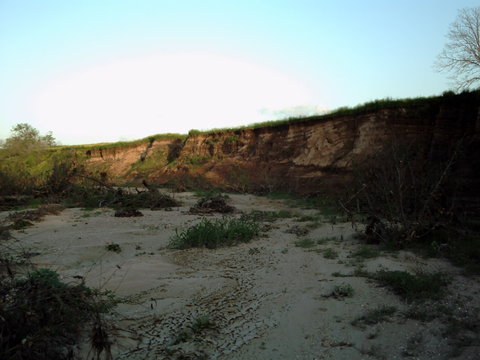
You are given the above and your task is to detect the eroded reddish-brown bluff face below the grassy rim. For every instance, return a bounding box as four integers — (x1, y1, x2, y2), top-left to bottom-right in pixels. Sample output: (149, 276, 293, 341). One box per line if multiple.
(85, 91, 480, 193)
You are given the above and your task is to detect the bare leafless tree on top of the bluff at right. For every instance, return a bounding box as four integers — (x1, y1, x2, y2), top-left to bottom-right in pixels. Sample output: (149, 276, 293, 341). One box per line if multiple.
(436, 7, 480, 90)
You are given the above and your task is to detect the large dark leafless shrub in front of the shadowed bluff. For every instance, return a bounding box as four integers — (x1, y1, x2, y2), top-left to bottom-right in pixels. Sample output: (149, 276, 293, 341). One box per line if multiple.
(342, 141, 462, 246)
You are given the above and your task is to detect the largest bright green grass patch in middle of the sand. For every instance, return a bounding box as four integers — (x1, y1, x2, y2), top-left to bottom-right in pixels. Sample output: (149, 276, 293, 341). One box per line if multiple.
(168, 217, 260, 249)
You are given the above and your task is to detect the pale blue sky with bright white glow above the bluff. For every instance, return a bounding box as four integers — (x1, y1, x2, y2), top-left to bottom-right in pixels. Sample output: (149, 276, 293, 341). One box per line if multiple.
(0, 0, 479, 145)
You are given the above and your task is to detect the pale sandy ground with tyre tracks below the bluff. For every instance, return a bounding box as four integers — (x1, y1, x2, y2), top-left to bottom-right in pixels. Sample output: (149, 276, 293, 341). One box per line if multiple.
(4, 193, 480, 360)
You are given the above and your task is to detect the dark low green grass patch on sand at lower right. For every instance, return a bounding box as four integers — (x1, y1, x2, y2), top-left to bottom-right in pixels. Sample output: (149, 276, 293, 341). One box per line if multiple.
(373, 270, 449, 302)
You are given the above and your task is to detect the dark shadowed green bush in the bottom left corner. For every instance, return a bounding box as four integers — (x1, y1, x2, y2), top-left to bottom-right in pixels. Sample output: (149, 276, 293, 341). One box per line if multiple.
(0, 269, 117, 360)
